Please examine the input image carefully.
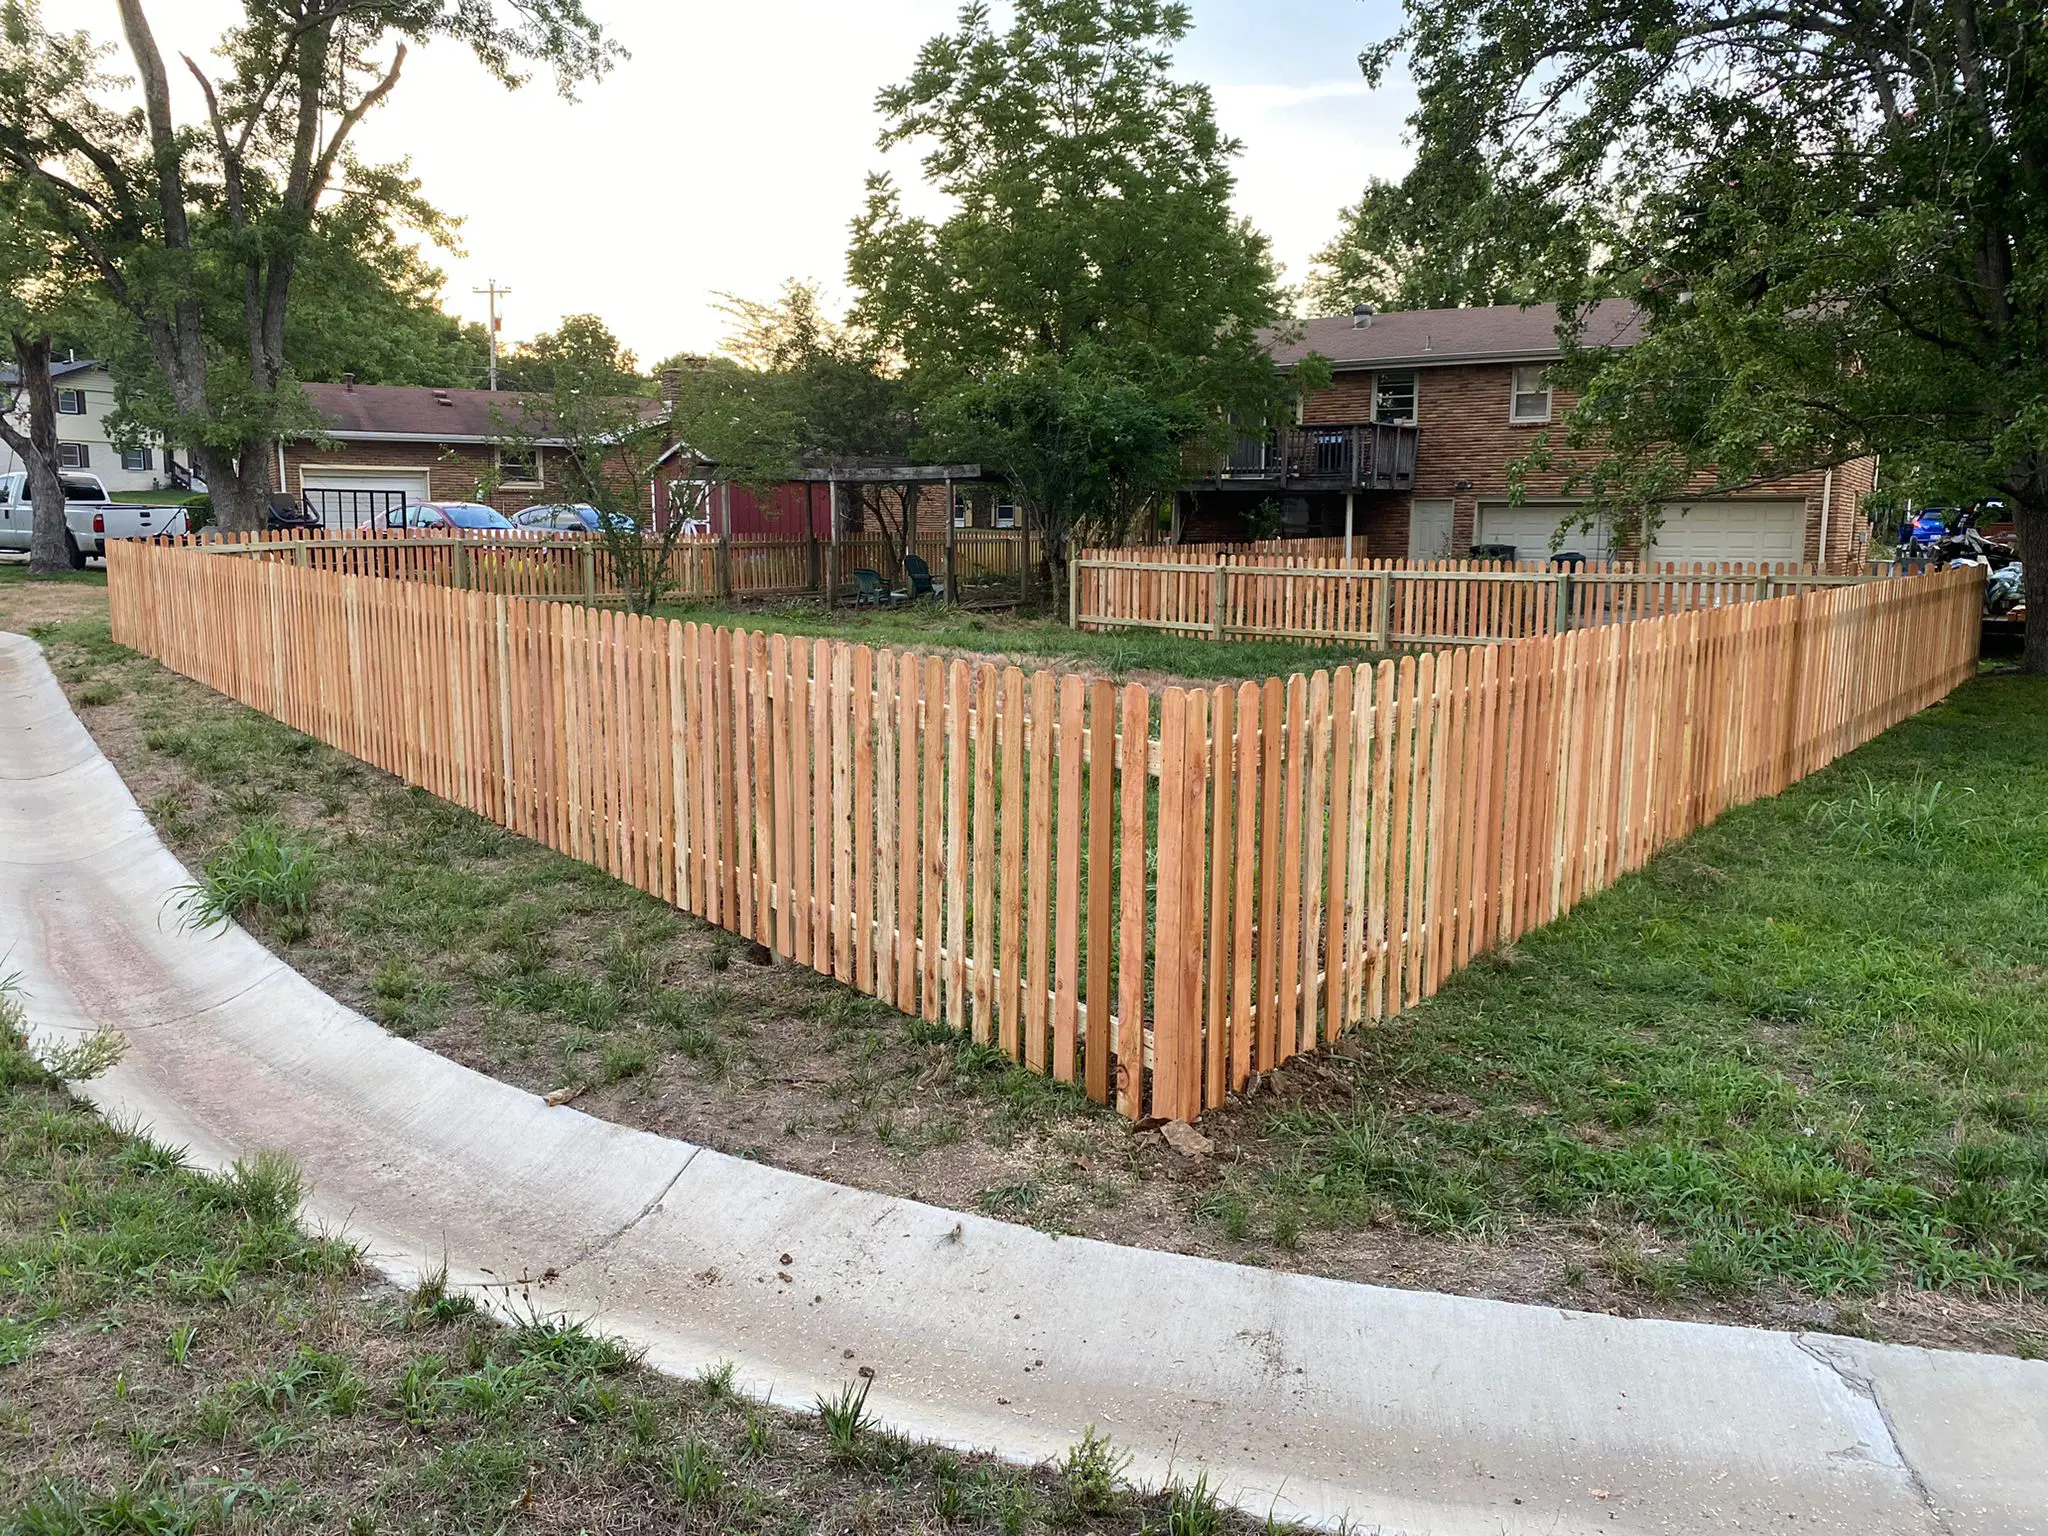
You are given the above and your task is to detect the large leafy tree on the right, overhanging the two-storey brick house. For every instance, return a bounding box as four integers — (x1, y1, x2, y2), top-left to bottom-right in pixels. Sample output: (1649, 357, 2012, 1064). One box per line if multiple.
(1364, 0, 2048, 672)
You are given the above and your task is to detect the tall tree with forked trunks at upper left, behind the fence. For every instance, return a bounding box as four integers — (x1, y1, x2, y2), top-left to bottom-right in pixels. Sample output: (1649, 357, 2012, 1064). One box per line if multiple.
(0, 0, 616, 528)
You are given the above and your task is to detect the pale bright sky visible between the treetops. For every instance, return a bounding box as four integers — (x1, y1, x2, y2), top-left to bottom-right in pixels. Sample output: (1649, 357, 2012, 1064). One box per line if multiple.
(103, 0, 1413, 365)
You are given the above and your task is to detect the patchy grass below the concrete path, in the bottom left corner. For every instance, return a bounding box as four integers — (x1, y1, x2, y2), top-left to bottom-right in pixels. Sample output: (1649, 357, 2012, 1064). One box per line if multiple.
(0, 995, 1260, 1536)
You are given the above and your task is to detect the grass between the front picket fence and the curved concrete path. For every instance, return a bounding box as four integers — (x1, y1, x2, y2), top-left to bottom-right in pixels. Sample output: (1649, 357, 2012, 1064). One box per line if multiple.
(19, 588, 2048, 1352)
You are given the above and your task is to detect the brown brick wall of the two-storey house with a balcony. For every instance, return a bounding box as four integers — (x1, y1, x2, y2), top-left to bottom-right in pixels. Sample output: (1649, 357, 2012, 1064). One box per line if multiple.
(1303, 362, 1876, 561)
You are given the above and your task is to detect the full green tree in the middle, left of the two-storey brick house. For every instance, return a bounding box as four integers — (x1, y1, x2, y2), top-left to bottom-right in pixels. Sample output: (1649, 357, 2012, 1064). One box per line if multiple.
(848, 0, 1290, 588)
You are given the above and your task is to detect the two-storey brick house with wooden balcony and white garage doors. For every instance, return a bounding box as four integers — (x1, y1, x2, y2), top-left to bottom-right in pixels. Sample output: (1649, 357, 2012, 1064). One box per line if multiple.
(1178, 301, 1876, 563)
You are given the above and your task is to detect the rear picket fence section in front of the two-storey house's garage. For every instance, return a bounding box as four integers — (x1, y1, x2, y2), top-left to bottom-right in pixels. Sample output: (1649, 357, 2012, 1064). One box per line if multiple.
(1069, 541, 1886, 649)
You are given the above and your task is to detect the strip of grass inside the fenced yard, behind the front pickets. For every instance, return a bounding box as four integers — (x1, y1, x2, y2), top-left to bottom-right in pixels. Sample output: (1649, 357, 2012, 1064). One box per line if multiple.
(662, 598, 1374, 680)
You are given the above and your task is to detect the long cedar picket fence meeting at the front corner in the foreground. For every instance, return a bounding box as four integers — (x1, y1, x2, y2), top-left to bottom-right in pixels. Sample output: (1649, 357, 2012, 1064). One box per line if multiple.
(109, 541, 1980, 1118)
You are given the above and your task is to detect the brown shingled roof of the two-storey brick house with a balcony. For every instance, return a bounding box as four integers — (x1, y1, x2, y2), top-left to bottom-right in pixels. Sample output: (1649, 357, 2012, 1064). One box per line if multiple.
(1272, 299, 1640, 369)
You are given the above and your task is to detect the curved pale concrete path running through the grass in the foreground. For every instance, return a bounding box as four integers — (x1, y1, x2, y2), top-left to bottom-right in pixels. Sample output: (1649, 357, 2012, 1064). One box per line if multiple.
(0, 635, 2048, 1536)
